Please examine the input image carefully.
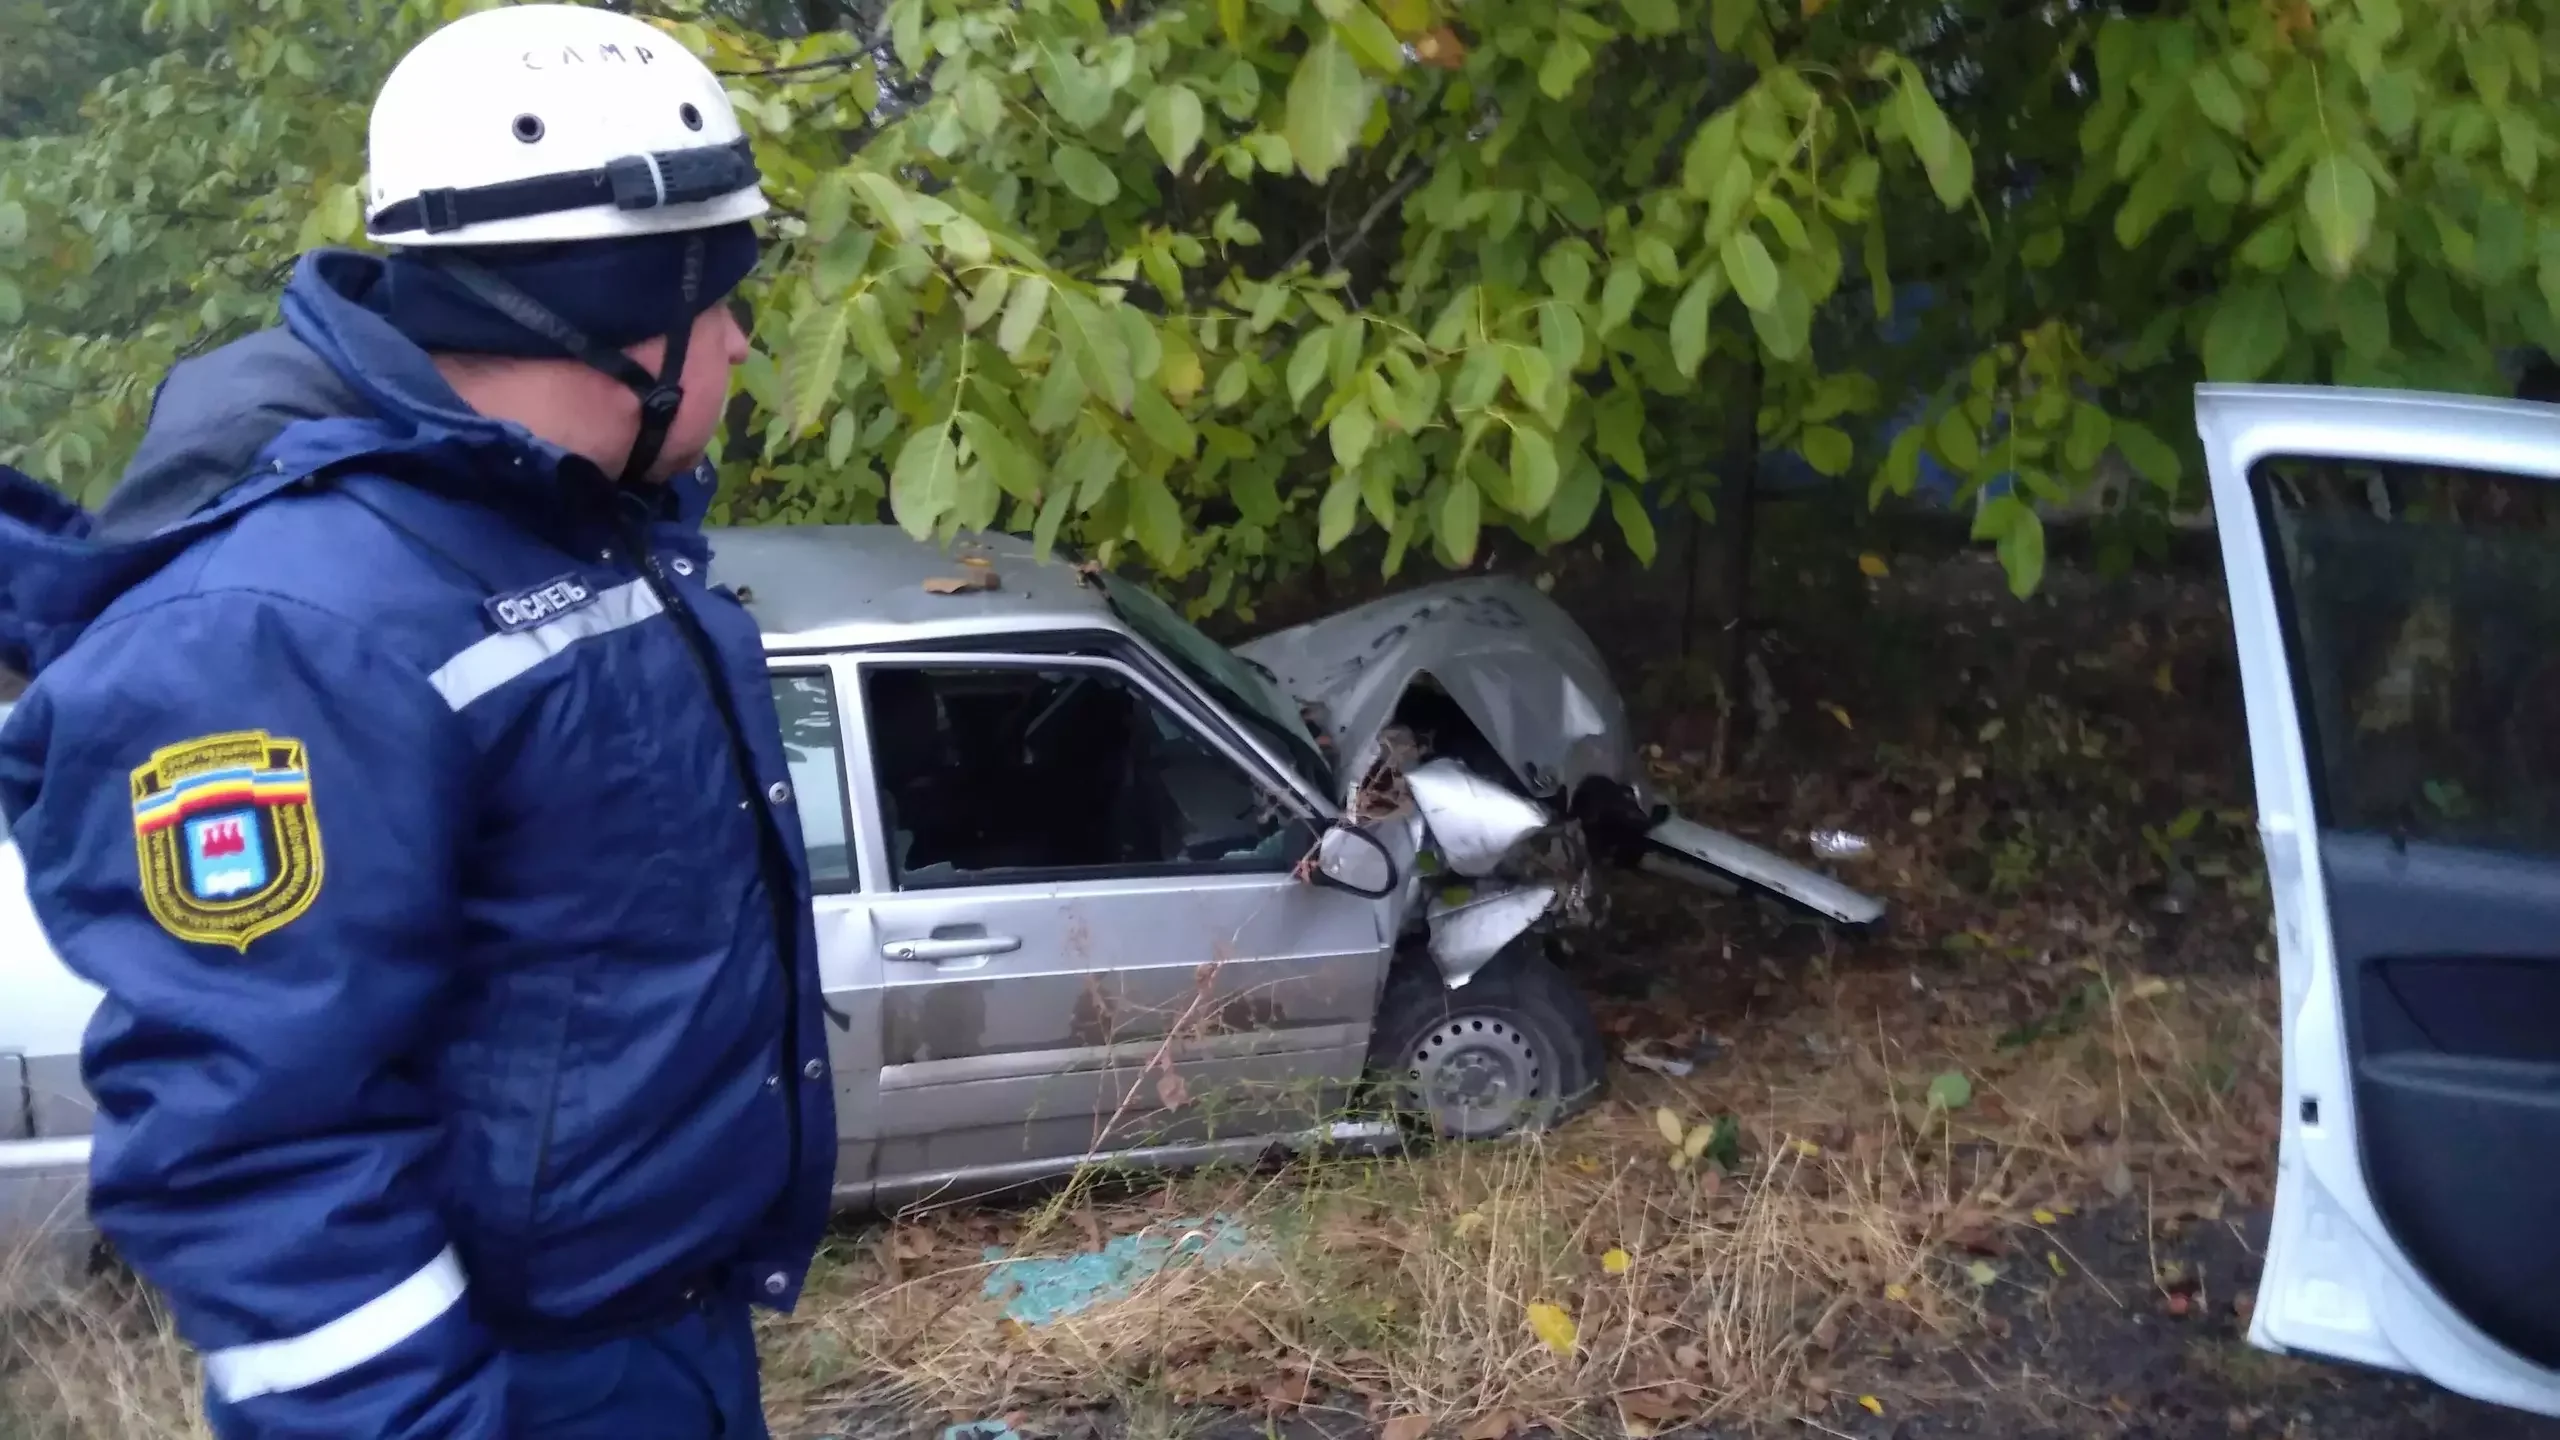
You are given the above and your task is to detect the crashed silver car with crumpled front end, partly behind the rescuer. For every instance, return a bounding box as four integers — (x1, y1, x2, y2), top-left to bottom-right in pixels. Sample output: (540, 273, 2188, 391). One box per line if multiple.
(0, 528, 1882, 1230)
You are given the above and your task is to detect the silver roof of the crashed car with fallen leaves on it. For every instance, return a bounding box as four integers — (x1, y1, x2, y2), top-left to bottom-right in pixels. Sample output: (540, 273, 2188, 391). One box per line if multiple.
(709, 525, 1126, 651)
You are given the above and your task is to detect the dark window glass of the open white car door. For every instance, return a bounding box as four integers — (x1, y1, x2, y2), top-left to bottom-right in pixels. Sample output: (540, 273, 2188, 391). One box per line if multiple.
(2253, 459, 2560, 853)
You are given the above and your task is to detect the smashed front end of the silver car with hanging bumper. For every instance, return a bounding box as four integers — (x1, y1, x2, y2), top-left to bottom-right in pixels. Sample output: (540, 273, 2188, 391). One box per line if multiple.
(1239, 579, 1884, 986)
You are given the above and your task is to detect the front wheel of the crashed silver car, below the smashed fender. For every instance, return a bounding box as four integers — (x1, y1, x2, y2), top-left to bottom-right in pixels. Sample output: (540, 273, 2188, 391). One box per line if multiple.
(1370, 940, 1605, 1140)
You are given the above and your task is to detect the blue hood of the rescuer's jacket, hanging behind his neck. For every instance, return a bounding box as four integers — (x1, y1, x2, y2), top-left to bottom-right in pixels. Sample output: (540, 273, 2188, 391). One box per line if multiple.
(0, 251, 717, 674)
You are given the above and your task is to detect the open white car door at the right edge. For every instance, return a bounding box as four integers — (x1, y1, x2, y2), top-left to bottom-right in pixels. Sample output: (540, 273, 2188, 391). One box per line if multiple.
(2196, 376, 2560, 1414)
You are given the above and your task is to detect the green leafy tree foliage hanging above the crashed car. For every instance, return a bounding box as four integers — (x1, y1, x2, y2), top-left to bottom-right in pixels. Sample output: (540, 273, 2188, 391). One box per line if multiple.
(0, 0, 2560, 605)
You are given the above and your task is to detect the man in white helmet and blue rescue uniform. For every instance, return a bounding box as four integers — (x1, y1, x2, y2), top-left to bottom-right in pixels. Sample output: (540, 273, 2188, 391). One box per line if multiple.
(0, 5, 835, 1440)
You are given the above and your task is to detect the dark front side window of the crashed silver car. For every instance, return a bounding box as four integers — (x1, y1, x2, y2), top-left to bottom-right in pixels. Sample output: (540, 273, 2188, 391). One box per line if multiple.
(863, 666, 1316, 889)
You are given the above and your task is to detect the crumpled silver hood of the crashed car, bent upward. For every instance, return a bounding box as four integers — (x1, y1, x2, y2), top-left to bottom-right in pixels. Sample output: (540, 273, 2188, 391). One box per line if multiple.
(1236, 577, 1641, 792)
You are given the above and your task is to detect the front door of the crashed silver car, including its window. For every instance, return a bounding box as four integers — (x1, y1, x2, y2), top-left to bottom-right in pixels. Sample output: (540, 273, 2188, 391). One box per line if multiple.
(837, 653, 1393, 1186)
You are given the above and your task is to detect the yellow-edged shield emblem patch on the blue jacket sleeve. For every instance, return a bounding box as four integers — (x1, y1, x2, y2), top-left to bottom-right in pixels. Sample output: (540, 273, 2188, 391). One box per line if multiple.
(133, 730, 320, 951)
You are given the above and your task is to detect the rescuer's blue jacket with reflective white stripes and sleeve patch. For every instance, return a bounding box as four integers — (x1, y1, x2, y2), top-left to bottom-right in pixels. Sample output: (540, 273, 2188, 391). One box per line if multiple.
(0, 251, 835, 1437)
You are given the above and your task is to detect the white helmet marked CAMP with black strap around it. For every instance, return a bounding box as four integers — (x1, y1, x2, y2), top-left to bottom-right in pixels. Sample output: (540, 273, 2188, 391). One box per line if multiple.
(366, 5, 765, 246)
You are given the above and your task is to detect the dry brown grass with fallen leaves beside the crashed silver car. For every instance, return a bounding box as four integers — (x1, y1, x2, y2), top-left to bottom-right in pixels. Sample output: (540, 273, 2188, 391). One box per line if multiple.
(747, 942, 2276, 1435)
